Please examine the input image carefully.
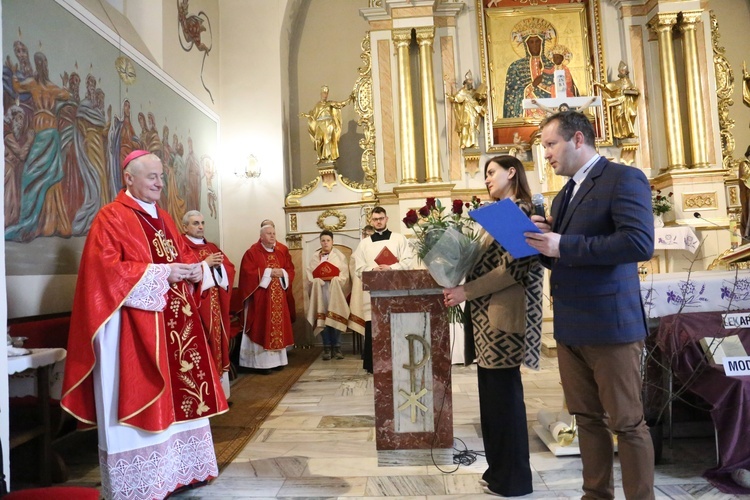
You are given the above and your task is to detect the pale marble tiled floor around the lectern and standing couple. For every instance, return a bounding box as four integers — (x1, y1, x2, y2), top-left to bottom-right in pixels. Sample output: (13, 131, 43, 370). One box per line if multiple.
(63, 354, 748, 500)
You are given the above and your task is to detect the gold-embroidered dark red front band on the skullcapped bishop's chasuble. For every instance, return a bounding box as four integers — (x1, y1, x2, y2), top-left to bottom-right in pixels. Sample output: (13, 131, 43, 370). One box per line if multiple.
(136, 212, 218, 422)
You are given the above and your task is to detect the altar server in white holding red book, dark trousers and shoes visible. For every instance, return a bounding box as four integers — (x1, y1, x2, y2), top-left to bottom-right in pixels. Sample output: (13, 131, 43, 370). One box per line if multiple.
(306, 229, 351, 361)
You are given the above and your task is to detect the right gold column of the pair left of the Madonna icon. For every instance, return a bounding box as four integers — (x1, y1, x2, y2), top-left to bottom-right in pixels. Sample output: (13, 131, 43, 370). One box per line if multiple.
(416, 26, 443, 182)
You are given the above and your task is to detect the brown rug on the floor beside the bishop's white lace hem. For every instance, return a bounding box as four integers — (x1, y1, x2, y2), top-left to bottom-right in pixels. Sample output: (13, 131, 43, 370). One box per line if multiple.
(210, 347, 321, 472)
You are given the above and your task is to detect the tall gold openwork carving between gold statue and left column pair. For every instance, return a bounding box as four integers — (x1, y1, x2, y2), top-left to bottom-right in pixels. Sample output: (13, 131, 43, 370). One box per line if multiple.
(352, 31, 378, 189)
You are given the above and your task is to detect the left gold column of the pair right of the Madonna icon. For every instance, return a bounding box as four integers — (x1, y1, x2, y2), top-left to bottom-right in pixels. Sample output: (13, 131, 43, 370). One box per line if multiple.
(648, 13, 685, 172)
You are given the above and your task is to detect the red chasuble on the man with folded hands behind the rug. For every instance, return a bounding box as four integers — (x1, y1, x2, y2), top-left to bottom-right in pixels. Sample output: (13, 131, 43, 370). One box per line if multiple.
(240, 241, 294, 350)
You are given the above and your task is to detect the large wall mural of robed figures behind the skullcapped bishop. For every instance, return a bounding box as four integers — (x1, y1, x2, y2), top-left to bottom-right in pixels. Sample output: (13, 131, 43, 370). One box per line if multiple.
(2, 0, 219, 275)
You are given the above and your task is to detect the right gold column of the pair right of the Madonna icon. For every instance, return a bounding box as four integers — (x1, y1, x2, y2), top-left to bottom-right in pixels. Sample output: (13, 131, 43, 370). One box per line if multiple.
(678, 11, 709, 168)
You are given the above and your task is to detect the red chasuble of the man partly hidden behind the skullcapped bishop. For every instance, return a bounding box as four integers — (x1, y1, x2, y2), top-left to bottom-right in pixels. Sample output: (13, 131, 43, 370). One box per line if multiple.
(182, 234, 235, 374)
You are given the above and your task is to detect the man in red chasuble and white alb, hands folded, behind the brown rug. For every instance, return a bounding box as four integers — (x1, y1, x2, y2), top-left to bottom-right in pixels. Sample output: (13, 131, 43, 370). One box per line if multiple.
(239, 220, 295, 373)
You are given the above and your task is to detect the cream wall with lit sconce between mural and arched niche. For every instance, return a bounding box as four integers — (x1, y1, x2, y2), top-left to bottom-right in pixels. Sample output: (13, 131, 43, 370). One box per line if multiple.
(217, 0, 288, 265)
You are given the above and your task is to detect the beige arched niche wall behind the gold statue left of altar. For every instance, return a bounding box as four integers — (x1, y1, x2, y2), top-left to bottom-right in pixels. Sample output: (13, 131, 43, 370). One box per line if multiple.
(288, 0, 369, 187)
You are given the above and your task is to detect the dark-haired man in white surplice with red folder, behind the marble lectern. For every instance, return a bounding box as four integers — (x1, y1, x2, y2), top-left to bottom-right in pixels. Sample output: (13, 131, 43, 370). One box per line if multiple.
(352, 207, 414, 373)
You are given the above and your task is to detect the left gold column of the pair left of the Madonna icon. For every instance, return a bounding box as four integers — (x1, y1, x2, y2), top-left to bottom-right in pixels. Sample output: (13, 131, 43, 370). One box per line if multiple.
(393, 28, 417, 184)
